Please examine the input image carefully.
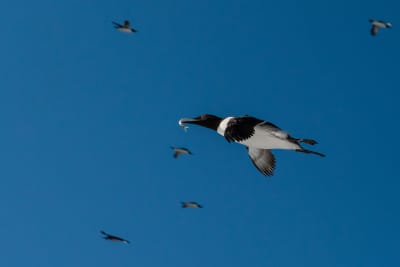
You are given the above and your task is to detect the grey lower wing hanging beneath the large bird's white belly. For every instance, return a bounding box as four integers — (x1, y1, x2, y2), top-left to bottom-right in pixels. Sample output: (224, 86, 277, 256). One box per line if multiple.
(247, 147, 275, 176)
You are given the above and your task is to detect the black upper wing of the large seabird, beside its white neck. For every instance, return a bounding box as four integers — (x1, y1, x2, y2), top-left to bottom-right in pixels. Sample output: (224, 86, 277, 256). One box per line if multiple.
(224, 116, 263, 142)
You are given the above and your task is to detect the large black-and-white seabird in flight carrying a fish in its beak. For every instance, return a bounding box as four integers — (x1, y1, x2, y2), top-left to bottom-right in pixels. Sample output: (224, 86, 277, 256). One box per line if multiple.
(179, 114, 325, 176)
